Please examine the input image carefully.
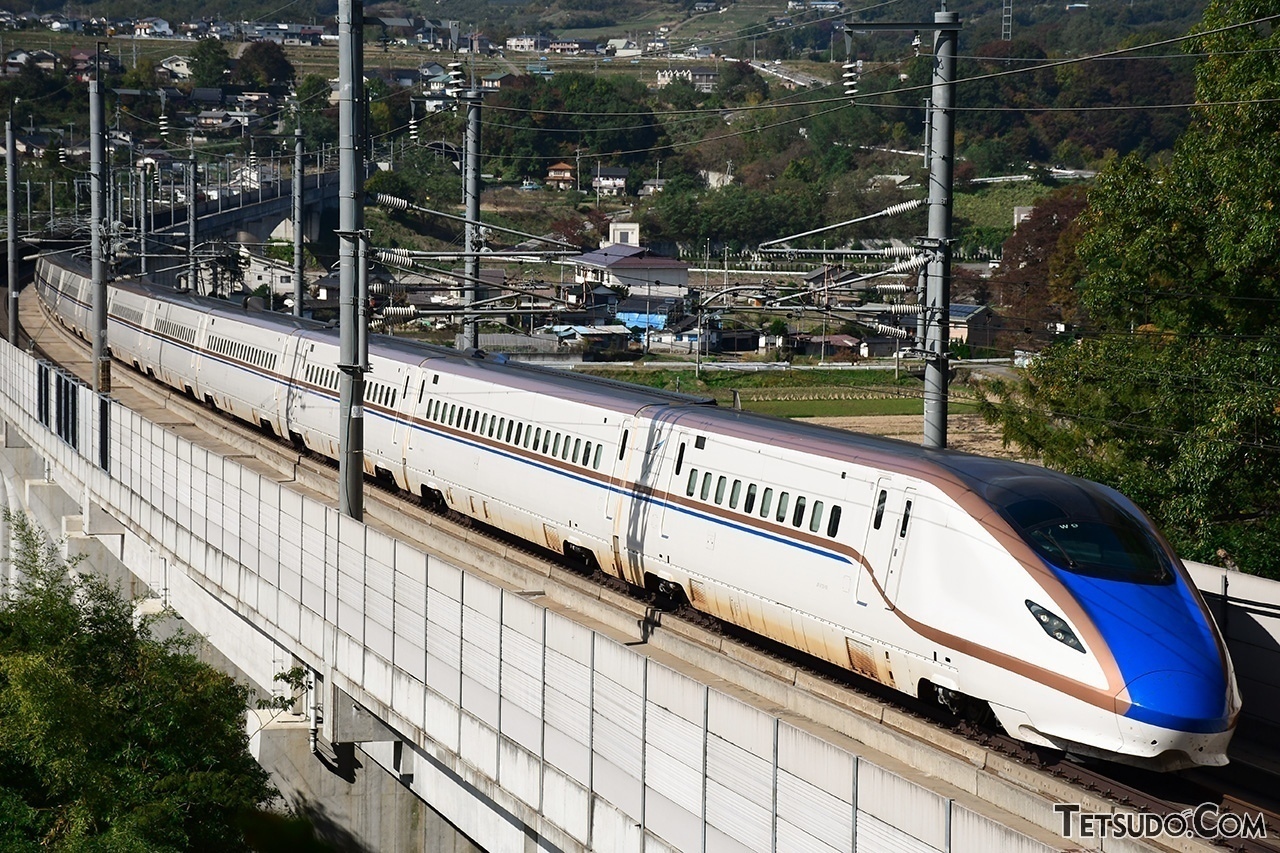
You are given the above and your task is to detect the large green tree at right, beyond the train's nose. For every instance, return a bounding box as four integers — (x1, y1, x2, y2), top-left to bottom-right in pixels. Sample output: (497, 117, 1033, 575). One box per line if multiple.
(986, 0, 1280, 576)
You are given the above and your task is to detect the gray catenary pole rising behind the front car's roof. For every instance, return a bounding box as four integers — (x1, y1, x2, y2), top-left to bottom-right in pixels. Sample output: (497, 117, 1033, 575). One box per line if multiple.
(924, 12, 960, 447)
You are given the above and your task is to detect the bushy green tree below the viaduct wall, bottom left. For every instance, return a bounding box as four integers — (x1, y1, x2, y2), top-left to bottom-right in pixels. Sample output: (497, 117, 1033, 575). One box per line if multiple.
(0, 514, 276, 852)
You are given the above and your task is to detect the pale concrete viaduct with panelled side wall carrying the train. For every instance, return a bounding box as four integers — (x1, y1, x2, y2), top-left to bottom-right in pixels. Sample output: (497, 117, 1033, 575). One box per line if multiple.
(0, 199, 1280, 853)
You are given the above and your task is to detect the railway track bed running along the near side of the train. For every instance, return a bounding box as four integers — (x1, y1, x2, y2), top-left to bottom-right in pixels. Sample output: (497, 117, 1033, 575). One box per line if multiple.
(23, 286, 1280, 853)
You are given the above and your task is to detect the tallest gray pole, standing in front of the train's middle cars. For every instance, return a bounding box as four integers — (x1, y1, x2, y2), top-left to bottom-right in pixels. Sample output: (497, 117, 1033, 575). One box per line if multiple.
(338, 0, 365, 521)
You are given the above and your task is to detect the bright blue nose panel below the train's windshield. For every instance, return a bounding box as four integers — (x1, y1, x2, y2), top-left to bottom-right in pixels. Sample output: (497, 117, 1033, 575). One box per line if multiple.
(1060, 573, 1231, 734)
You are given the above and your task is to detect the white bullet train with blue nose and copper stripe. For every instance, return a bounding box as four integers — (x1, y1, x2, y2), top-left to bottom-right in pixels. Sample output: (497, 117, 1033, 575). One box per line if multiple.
(36, 249, 1240, 770)
